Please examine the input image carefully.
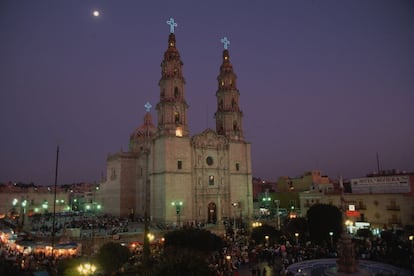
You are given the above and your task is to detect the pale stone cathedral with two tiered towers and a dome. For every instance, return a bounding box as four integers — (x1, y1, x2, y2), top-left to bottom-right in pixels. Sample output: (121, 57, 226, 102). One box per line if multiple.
(97, 18, 253, 224)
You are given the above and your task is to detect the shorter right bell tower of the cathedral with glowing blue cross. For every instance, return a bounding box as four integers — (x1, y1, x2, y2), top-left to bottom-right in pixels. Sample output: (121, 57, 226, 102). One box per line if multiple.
(215, 37, 244, 141)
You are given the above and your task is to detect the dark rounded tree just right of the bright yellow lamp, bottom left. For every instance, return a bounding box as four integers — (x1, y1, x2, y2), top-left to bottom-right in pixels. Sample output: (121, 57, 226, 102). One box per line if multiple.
(96, 242, 131, 272)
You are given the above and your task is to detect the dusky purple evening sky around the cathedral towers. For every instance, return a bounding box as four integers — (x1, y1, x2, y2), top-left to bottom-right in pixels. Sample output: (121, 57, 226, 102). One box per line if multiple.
(0, 0, 414, 185)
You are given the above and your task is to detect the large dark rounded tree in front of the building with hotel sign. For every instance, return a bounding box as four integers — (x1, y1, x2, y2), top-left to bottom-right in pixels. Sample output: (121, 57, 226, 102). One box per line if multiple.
(306, 204, 342, 244)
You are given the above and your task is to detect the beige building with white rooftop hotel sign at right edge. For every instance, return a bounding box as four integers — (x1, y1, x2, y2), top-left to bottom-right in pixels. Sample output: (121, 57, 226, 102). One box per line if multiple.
(300, 171, 414, 231)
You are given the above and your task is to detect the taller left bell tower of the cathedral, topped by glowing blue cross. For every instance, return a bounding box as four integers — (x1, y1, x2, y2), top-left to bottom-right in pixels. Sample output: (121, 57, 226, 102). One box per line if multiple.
(156, 18, 189, 137)
